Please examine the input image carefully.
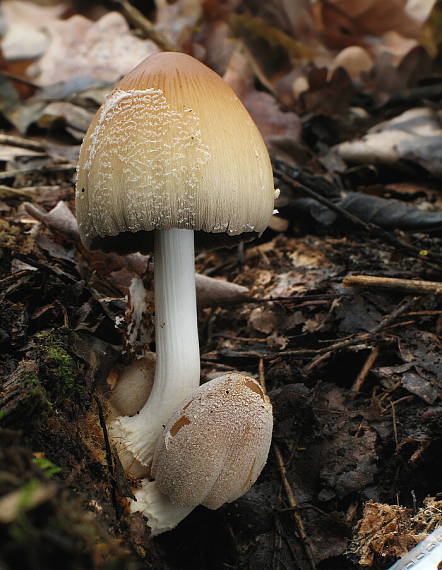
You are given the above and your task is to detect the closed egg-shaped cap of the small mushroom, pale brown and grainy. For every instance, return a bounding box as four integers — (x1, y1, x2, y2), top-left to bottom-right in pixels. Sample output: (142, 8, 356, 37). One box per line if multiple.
(152, 373, 273, 509)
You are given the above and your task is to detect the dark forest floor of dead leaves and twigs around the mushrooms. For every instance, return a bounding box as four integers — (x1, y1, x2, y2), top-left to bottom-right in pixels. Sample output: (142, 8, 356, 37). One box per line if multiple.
(0, 1, 442, 570)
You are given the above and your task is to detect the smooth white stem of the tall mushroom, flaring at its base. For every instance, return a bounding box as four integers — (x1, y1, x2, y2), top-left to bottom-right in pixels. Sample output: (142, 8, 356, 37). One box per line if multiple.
(111, 229, 200, 467)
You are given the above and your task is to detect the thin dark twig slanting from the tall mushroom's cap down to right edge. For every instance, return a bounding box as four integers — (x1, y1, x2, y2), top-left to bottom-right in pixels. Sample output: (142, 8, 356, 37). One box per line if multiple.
(274, 161, 442, 264)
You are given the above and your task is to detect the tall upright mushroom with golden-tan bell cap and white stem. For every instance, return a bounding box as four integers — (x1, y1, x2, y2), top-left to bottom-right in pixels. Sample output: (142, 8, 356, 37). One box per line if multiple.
(76, 52, 274, 466)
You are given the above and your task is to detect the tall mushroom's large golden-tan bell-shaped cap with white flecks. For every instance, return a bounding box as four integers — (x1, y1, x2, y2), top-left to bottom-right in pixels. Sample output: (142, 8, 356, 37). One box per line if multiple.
(76, 52, 274, 253)
